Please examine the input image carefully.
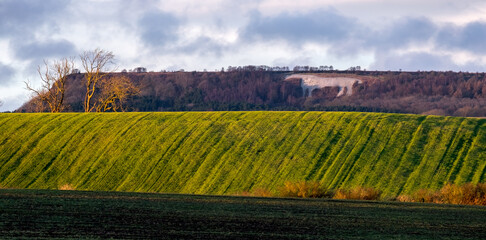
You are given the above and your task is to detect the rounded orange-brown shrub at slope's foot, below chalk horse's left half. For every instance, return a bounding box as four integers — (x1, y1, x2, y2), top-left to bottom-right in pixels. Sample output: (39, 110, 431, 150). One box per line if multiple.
(280, 181, 329, 198)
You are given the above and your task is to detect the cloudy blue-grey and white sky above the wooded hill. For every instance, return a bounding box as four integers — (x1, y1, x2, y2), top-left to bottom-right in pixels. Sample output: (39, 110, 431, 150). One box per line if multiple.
(0, 0, 486, 112)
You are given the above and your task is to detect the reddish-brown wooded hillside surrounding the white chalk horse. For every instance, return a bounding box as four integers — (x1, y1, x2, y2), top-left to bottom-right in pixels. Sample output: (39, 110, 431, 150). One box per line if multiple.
(17, 69, 486, 117)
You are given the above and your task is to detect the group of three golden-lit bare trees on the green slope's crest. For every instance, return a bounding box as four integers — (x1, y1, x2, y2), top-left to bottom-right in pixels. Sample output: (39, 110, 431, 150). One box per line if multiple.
(25, 48, 139, 113)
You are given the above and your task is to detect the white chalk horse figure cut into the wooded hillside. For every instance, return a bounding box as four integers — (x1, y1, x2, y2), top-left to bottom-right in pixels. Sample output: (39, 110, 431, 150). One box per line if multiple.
(285, 74, 362, 97)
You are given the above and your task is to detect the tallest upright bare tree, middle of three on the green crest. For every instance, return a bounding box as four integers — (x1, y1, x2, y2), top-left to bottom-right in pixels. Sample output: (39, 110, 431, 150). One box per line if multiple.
(80, 48, 115, 112)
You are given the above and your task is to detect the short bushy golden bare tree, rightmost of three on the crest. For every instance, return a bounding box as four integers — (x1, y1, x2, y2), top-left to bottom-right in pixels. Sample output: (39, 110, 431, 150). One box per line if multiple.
(96, 76, 140, 112)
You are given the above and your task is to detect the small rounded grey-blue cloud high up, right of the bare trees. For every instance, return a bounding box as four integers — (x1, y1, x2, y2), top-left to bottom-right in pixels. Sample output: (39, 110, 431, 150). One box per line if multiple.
(138, 11, 181, 46)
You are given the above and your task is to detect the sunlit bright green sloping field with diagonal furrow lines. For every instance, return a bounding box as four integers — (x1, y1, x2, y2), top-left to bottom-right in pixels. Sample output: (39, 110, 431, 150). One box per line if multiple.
(0, 112, 486, 196)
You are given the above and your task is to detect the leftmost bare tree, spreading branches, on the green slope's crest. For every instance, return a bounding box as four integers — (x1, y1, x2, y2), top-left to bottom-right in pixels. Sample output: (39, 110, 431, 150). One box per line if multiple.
(24, 58, 74, 112)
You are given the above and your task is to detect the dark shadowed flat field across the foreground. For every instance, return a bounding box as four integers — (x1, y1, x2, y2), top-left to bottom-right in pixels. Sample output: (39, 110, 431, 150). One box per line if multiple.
(0, 190, 486, 240)
